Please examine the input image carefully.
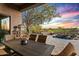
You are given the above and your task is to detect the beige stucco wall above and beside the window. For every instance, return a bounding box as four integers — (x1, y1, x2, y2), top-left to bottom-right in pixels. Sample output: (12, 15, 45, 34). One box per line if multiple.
(0, 4, 22, 33)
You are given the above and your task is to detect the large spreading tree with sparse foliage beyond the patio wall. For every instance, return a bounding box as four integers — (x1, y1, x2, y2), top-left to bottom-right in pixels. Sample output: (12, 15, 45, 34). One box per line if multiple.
(23, 4, 59, 32)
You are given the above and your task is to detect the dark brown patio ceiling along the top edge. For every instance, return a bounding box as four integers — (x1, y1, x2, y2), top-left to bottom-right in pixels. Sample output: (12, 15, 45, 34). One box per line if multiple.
(6, 3, 43, 11)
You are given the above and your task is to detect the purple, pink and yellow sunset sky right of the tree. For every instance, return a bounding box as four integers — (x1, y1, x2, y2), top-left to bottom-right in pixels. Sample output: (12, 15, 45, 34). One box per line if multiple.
(42, 3, 79, 28)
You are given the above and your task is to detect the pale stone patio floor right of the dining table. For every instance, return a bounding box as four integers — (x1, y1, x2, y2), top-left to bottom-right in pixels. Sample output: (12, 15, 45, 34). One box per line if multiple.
(46, 36, 79, 55)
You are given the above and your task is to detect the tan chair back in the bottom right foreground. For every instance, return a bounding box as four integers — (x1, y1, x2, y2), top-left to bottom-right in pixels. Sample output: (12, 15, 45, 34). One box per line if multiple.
(53, 43, 76, 56)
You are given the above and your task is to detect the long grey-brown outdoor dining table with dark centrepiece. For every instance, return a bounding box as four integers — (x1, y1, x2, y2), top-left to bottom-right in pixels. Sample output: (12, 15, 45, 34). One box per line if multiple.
(3, 40, 55, 56)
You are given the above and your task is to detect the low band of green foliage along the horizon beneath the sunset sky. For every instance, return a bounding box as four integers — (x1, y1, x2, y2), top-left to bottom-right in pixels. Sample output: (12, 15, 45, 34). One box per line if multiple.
(48, 28, 78, 35)
